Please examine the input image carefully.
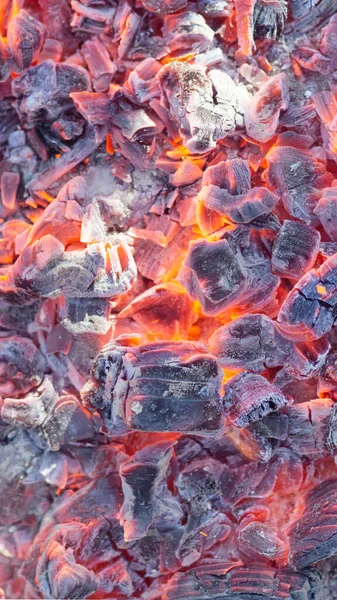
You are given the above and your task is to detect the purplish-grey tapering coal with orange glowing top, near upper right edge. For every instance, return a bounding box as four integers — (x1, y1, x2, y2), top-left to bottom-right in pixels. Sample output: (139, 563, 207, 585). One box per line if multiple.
(265, 146, 332, 225)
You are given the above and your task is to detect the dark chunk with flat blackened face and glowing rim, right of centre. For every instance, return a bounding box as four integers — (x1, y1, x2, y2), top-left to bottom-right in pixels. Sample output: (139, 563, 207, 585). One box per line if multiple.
(178, 240, 246, 316)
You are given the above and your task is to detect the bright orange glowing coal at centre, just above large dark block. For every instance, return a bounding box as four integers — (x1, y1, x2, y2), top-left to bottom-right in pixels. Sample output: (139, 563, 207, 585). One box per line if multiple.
(118, 283, 197, 340)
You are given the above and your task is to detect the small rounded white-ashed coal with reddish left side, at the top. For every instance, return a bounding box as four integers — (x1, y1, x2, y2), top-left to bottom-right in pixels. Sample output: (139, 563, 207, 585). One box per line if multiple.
(163, 11, 214, 52)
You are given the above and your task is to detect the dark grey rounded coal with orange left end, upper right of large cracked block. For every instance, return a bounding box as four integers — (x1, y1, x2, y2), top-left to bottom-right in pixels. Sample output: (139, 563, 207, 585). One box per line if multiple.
(209, 314, 293, 373)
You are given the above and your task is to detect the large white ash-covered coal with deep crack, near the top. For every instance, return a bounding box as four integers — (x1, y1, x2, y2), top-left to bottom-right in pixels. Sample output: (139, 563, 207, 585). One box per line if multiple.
(159, 62, 243, 153)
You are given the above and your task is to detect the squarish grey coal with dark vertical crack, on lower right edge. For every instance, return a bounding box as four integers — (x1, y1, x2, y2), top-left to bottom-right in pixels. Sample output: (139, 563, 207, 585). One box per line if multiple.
(284, 398, 337, 459)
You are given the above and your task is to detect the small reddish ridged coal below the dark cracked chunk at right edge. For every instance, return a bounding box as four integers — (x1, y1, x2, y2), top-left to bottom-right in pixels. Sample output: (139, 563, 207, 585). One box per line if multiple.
(284, 338, 331, 379)
